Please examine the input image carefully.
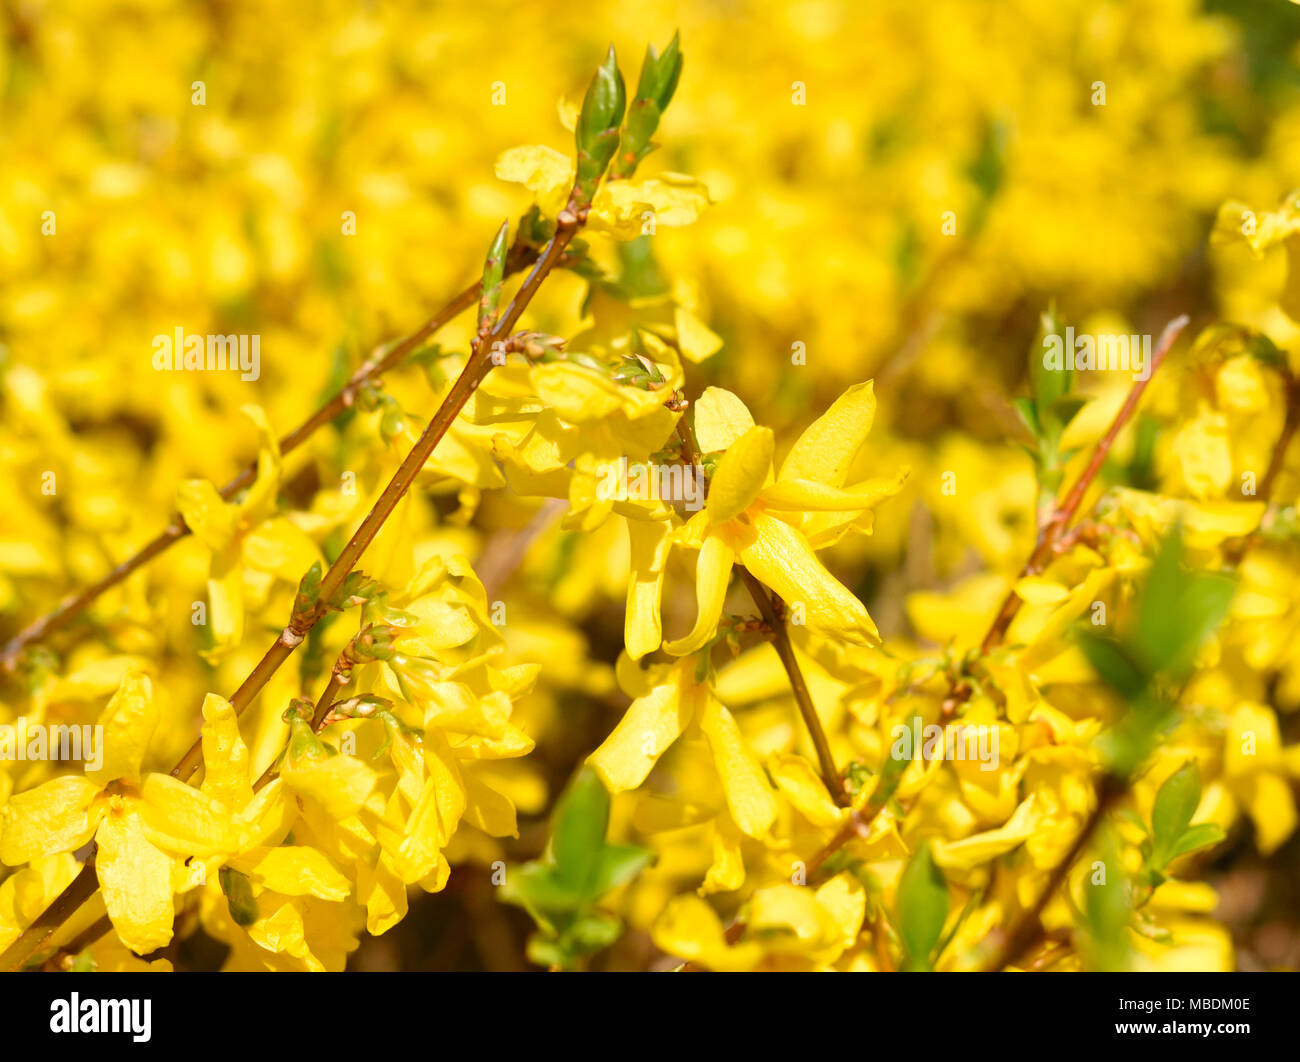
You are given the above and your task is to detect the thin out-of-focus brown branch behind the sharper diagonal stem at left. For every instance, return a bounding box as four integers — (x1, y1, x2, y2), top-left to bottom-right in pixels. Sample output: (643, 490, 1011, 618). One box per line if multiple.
(0, 242, 537, 671)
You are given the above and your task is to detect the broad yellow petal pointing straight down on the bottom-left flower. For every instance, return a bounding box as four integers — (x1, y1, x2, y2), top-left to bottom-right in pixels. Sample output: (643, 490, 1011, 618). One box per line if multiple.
(95, 798, 173, 955)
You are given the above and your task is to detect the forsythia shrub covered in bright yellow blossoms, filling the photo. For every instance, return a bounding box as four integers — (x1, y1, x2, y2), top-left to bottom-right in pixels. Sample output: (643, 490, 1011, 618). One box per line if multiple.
(0, 0, 1300, 971)
